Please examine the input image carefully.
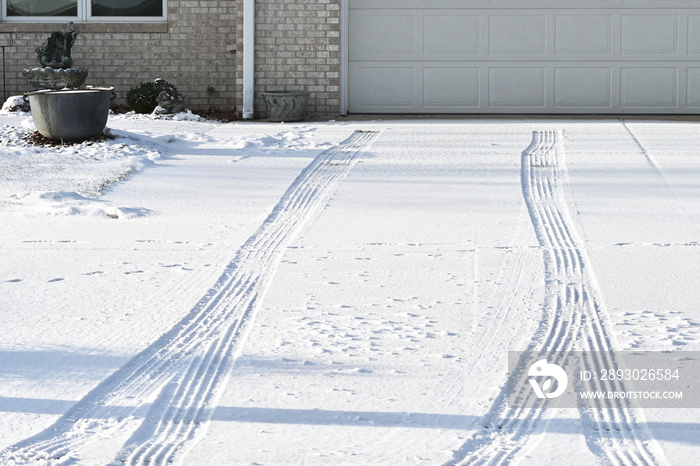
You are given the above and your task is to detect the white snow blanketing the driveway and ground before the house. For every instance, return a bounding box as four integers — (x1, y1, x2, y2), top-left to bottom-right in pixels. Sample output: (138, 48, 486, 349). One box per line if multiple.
(0, 107, 700, 465)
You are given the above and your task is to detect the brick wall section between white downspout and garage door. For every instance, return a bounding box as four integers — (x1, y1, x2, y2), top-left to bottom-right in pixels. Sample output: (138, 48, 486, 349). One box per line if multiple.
(236, 0, 340, 117)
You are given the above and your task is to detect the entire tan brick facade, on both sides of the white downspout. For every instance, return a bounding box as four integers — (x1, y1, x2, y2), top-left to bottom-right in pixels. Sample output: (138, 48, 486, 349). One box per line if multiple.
(0, 0, 340, 117)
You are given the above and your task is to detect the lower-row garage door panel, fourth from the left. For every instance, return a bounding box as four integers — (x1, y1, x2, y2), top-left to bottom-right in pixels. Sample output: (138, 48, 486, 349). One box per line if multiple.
(554, 68, 612, 108)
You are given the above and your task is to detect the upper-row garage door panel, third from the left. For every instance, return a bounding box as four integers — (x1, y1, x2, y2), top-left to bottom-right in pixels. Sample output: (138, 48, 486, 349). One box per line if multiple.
(489, 14, 546, 55)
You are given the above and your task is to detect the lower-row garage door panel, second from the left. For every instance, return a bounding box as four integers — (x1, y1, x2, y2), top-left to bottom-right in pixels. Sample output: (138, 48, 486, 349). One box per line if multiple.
(423, 67, 480, 109)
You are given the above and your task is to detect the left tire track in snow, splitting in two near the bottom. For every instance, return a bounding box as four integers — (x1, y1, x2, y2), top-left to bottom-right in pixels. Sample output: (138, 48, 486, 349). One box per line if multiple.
(0, 131, 378, 465)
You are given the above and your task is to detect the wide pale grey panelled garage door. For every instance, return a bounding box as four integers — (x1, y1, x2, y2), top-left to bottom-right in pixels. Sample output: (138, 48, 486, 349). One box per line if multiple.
(348, 0, 700, 114)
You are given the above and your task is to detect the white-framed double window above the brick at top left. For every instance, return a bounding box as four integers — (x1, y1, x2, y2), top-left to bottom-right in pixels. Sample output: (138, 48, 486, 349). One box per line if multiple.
(1, 0, 167, 22)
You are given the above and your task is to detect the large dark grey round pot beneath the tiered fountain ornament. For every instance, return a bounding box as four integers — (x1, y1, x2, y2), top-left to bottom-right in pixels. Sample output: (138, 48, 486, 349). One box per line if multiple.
(26, 88, 112, 140)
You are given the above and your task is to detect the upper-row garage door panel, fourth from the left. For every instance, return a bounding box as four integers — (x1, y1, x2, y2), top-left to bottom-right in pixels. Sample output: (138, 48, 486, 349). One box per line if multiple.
(554, 14, 613, 55)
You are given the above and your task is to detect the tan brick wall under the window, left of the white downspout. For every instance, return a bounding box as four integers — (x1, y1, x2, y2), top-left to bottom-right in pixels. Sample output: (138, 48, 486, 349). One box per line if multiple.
(0, 0, 237, 110)
